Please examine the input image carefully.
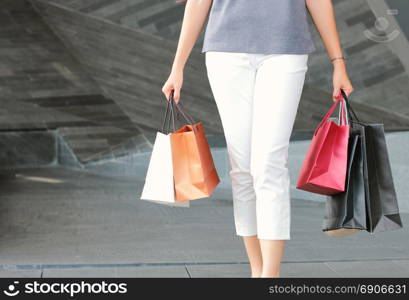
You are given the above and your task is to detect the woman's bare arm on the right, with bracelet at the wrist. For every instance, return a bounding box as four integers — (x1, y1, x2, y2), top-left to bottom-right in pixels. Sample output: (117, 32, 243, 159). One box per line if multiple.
(306, 0, 354, 101)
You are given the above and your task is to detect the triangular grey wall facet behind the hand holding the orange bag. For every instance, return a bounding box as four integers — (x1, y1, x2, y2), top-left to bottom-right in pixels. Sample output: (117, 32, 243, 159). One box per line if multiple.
(32, 1, 225, 133)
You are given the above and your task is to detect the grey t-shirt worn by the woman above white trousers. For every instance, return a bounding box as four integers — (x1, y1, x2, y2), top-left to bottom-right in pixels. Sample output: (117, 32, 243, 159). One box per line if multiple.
(202, 0, 315, 54)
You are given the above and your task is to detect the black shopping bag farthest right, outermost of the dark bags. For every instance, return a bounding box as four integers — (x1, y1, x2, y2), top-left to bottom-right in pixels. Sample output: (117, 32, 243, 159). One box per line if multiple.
(345, 91, 403, 233)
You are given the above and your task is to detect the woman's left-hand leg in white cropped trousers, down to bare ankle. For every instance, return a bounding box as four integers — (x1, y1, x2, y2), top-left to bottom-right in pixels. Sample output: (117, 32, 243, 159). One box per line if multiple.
(206, 52, 262, 277)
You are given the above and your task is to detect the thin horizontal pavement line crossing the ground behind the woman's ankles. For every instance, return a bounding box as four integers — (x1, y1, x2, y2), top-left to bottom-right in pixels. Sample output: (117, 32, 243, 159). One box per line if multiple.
(0, 257, 409, 270)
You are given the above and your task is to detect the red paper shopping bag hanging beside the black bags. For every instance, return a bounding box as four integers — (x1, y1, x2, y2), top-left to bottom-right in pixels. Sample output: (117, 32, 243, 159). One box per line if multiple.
(296, 97, 349, 195)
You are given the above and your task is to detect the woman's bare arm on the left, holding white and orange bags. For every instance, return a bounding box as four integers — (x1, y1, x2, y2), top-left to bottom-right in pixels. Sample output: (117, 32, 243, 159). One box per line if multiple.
(162, 0, 213, 103)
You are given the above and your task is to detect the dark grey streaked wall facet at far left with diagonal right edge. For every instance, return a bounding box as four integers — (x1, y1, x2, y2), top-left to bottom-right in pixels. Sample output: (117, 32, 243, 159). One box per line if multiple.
(0, 0, 145, 161)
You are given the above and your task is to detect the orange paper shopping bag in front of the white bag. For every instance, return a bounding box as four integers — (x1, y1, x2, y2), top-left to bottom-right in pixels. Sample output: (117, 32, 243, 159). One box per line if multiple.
(170, 94, 220, 201)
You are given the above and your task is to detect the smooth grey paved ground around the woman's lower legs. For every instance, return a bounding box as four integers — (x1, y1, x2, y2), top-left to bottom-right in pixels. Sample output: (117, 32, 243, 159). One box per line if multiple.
(0, 169, 409, 277)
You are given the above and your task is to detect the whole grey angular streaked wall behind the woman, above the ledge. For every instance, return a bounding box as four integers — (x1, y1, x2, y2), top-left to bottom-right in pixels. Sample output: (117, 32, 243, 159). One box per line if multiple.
(0, 0, 409, 167)
